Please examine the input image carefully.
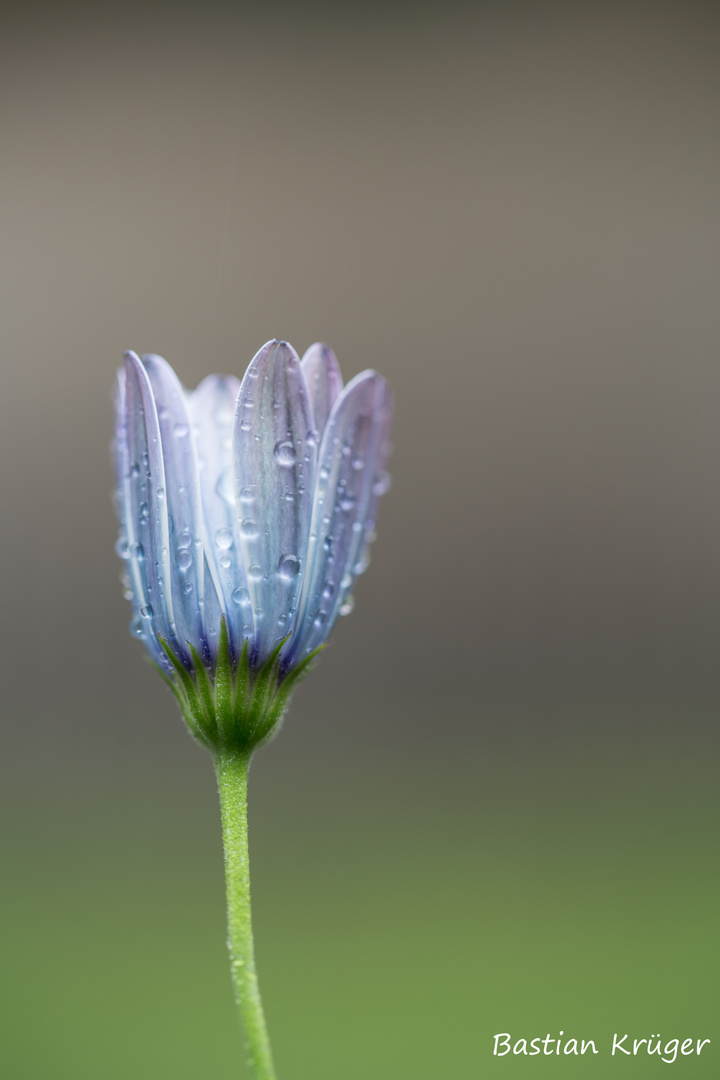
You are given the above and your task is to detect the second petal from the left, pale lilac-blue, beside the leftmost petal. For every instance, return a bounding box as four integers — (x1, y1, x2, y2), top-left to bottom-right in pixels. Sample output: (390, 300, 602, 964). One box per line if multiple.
(142, 353, 215, 660)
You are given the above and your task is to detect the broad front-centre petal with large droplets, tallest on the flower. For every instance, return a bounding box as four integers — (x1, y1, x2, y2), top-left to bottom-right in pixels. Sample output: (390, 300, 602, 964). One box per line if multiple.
(233, 341, 317, 662)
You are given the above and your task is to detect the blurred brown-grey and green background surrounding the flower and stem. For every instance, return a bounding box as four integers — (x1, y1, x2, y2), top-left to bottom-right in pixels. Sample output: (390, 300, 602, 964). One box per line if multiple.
(0, 0, 720, 1080)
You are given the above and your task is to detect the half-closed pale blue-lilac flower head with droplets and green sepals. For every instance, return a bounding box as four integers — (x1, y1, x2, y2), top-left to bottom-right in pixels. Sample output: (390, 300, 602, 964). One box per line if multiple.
(113, 340, 392, 744)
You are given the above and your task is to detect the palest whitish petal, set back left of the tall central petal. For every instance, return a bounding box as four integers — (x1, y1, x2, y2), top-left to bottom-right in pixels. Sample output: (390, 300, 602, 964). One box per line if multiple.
(190, 375, 253, 658)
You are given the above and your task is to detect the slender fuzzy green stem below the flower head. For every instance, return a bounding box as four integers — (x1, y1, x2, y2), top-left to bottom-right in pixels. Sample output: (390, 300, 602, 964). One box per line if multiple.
(215, 751, 275, 1080)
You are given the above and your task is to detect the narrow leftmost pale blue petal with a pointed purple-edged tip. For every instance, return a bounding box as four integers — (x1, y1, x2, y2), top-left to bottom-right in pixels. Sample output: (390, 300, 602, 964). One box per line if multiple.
(123, 352, 184, 663)
